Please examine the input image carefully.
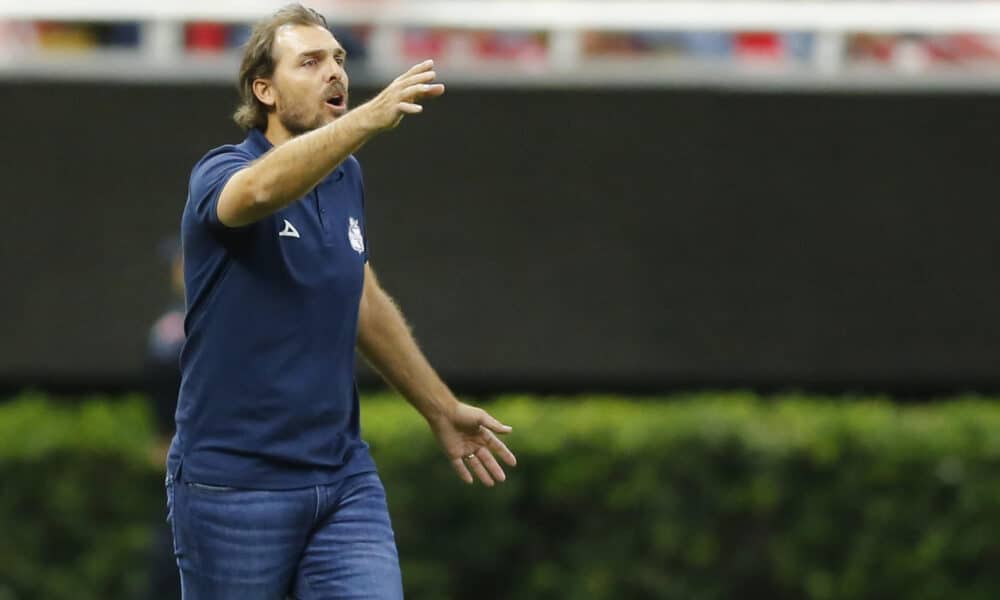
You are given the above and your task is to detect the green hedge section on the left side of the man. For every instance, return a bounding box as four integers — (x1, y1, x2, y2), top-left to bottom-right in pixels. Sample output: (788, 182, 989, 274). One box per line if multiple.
(0, 395, 163, 600)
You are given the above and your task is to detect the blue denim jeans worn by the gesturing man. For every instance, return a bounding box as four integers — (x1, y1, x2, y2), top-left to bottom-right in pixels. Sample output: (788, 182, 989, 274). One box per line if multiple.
(166, 473, 403, 600)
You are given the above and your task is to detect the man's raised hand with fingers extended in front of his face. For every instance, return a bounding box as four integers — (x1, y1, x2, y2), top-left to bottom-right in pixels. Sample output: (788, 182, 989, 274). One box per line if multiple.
(358, 60, 444, 131)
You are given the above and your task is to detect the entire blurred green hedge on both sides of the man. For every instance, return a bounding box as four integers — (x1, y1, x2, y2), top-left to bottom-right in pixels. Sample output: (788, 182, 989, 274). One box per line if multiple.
(0, 393, 1000, 600)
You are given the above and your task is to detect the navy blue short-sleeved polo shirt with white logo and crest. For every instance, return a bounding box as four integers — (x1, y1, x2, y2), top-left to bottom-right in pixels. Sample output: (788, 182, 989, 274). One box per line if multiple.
(168, 129, 375, 489)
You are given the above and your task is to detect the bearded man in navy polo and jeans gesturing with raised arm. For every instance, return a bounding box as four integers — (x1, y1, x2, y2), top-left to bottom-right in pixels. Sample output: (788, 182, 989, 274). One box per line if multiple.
(167, 5, 515, 600)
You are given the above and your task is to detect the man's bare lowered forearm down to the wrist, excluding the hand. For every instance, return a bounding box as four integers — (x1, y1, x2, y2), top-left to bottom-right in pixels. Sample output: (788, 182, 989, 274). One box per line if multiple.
(358, 283, 457, 421)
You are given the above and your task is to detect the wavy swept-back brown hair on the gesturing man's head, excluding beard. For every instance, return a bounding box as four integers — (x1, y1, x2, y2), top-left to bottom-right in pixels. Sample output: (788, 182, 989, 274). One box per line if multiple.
(233, 4, 328, 130)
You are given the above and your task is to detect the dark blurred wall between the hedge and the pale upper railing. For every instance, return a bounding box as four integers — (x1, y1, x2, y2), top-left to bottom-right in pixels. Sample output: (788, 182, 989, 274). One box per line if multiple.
(0, 83, 1000, 388)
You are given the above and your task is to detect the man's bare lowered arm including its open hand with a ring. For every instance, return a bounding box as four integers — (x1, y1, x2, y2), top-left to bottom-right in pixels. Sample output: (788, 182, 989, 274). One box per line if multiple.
(358, 265, 517, 486)
